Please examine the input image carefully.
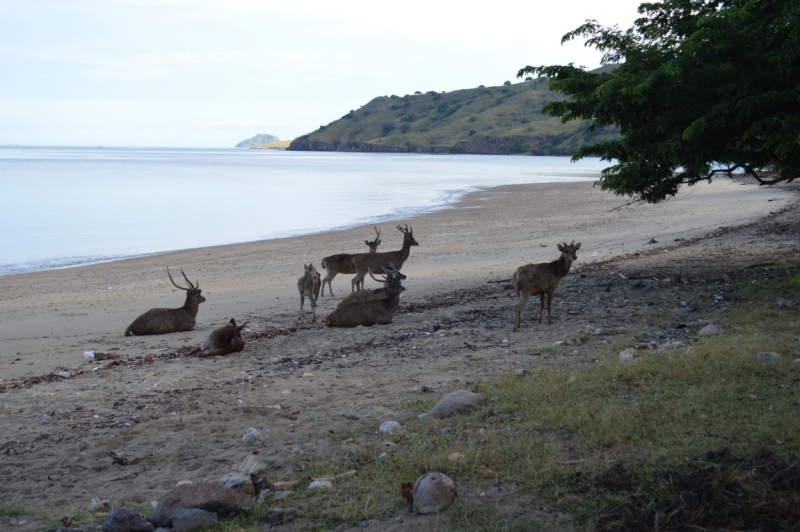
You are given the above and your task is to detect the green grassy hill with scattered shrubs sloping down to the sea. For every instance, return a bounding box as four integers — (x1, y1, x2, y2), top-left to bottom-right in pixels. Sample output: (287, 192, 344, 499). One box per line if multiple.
(288, 78, 617, 155)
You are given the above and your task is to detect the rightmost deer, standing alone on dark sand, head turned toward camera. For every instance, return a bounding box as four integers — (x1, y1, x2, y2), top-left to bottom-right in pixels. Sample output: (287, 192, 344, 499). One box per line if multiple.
(514, 240, 581, 332)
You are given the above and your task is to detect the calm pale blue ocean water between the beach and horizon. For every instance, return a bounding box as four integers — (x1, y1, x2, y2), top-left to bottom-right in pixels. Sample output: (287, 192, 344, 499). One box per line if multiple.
(0, 147, 607, 275)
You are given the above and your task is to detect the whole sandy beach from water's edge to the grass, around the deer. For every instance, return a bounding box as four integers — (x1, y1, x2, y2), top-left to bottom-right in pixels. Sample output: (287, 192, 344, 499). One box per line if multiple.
(0, 179, 800, 530)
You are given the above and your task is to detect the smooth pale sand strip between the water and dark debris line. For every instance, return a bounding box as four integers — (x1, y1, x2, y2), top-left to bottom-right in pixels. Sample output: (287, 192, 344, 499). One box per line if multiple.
(0, 180, 796, 379)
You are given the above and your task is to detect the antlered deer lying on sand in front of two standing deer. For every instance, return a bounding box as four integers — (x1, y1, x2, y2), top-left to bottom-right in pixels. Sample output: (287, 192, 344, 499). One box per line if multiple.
(325, 264, 405, 327)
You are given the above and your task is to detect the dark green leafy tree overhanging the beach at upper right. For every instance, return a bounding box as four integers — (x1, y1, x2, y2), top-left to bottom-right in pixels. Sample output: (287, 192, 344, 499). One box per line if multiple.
(518, 0, 800, 203)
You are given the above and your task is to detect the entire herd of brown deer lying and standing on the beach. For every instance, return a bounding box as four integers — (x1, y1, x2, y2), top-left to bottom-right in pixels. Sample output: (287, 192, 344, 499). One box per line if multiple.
(125, 225, 581, 357)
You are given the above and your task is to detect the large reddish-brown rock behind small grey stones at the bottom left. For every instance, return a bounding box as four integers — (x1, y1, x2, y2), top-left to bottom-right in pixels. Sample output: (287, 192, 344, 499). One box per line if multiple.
(152, 483, 253, 527)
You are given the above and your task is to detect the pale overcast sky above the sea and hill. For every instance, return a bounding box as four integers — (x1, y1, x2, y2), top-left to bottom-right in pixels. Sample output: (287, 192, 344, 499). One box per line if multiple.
(0, 0, 641, 147)
